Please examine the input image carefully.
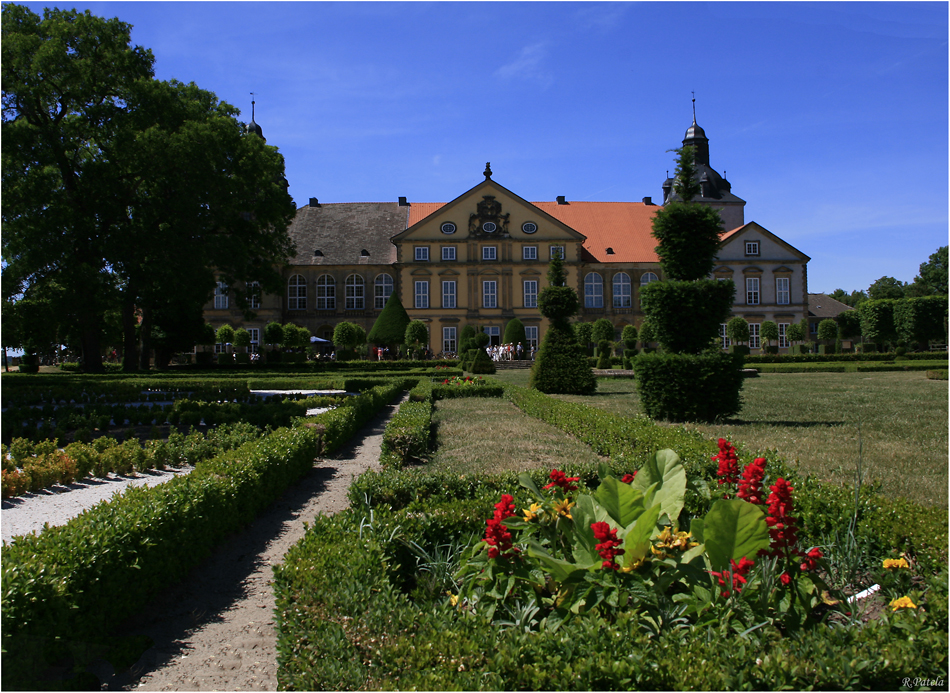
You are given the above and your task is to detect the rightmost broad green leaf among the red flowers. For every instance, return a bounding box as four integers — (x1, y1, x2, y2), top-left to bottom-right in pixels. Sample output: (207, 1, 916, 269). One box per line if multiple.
(703, 499, 769, 570)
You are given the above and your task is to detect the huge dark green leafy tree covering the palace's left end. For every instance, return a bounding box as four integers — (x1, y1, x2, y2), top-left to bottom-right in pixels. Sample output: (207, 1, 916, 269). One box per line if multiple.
(2, 5, 294, 371)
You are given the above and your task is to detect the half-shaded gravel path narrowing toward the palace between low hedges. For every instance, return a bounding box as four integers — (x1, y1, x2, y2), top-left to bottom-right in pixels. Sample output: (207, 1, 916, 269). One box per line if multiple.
(2, 392, 408, 691)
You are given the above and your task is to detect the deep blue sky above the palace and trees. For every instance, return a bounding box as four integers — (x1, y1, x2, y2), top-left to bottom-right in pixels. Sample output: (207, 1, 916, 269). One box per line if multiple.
(16, 2, 950, 292)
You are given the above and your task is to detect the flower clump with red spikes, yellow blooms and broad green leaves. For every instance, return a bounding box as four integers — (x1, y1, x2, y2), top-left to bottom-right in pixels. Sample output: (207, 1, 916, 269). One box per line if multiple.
(449, 441, 839, 632)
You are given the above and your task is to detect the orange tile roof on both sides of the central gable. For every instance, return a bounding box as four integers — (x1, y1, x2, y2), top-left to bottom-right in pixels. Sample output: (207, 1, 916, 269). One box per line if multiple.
(408, 201, 659, 262)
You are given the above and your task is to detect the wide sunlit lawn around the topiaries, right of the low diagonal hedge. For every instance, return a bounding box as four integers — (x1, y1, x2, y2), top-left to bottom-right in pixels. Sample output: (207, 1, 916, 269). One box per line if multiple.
(496, 371, 948, 507)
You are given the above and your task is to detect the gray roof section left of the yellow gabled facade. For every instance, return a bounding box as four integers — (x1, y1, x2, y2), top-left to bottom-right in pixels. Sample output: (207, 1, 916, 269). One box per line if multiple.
(288, 202, 409, 265)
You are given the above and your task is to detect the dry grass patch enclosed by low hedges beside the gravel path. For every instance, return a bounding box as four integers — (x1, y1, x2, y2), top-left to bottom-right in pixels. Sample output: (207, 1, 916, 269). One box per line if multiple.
(421, 397, 600, 474)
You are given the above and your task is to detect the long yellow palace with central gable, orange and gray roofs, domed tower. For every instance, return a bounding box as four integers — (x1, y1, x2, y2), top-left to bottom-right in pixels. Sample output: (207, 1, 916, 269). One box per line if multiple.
(205, 113, 810, 354)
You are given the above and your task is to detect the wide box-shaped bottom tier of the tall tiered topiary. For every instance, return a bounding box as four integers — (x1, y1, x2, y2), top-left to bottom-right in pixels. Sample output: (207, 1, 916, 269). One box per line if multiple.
(633, 353, 743, 422)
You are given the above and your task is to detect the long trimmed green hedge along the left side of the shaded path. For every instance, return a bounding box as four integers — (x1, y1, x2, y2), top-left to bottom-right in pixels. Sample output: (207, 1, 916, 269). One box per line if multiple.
(2, 381, 414, 690)
